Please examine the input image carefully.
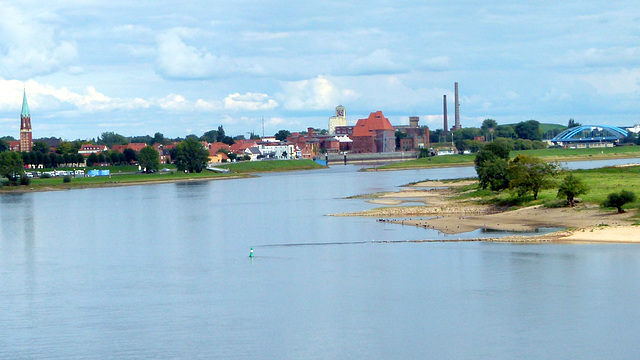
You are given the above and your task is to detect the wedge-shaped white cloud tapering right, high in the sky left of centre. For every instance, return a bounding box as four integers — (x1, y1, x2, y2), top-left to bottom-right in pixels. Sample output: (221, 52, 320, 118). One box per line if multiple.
(157, 28, 263, 79)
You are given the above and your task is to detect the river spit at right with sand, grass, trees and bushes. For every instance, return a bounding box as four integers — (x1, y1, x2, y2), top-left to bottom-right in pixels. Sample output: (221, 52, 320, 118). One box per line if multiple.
(334, 142, 640, 242)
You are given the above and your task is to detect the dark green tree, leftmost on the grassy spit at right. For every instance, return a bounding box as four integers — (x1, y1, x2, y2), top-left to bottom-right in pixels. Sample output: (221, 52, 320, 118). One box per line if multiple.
(474, 141, 509, 191)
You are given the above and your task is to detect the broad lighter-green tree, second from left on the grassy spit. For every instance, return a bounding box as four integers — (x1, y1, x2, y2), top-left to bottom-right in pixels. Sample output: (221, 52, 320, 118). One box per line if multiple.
(507, 155, 559, 200)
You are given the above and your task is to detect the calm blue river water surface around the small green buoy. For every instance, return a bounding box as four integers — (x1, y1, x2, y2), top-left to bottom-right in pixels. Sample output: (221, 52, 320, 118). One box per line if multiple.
(0, 166, 640, 359)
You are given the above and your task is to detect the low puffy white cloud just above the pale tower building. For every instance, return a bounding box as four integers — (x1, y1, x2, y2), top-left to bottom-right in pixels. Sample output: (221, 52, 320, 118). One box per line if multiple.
(279, 76, 358, 110)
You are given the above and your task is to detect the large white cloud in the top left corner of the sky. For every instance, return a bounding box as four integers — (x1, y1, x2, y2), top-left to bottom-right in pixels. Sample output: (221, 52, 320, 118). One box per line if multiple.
(0, 3, 78, 78)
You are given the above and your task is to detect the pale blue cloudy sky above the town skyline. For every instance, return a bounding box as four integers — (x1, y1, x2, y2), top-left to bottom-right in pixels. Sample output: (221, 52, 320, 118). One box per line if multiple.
(0, 0, 640, 140)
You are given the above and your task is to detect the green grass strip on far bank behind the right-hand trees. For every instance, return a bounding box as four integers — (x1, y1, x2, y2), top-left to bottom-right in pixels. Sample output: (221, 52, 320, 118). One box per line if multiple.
(378, 146, 640, 170)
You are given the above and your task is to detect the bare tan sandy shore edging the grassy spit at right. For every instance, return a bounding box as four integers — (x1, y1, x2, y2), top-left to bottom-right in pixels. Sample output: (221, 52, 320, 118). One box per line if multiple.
(330, 181, 640, 242)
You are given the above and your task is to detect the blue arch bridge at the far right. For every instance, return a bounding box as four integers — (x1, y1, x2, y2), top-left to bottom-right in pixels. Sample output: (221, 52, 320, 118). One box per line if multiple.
(551, 125, 629, 147)
